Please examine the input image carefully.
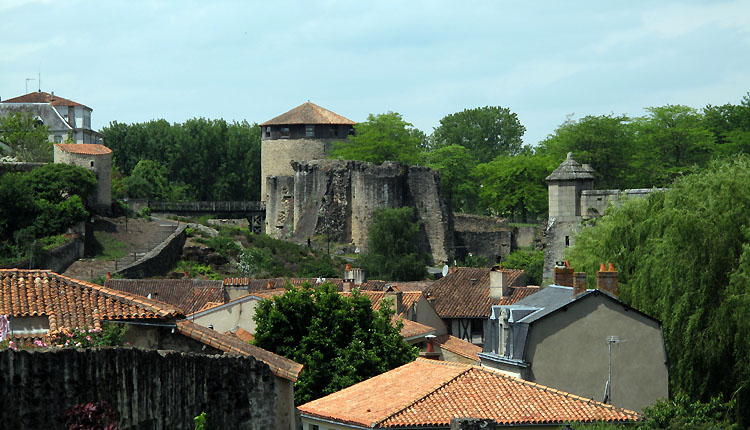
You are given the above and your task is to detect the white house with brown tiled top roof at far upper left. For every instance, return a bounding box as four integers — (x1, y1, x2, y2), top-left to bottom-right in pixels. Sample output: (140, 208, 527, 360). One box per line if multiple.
(0, 90, 103, 144)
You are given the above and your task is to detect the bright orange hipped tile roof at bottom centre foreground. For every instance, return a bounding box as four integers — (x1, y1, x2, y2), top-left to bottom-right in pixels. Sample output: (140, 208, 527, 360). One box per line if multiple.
(298, 359, 640, 428)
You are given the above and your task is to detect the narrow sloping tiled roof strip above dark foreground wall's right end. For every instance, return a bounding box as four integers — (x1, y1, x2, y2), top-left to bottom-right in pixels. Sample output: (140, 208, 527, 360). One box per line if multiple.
(177, 320, 302, 382)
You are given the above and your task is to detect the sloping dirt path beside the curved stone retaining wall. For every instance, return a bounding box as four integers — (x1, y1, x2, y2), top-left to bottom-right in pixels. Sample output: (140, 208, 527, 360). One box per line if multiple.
(63, 217, 177, 281)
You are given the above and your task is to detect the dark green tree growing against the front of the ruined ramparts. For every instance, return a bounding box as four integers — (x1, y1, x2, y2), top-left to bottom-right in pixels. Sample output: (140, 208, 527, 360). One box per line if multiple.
(358, 207, 429, 281)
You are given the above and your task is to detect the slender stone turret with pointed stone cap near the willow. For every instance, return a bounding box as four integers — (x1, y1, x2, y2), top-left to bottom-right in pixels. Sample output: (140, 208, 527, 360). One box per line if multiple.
(544, 152, 594, 280)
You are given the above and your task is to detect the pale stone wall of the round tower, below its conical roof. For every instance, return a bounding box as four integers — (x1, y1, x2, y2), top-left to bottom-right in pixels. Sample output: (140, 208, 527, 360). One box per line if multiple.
(260, 139, 333, 201)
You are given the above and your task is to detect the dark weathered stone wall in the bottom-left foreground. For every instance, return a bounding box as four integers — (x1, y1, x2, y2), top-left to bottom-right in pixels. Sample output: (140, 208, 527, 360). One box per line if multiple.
(0, 348, 280, 430)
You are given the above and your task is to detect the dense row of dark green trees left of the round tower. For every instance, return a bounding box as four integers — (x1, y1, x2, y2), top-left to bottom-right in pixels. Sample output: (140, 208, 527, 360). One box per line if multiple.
(102, 118, 260, 200)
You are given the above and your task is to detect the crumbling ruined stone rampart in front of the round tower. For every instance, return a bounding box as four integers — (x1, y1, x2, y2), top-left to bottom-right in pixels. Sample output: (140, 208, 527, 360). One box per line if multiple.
(266, 160, 453, 264)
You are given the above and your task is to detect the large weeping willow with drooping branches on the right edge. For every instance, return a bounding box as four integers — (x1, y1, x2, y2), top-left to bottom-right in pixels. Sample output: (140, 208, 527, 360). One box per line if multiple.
(568, 156, 750, 425)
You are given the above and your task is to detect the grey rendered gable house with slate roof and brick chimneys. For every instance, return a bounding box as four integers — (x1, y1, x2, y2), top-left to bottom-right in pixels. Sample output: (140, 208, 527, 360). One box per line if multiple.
(479, 267, 668, 411)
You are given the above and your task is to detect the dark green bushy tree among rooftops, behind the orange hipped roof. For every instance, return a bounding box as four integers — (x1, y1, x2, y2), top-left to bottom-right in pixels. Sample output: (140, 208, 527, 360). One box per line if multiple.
(254, 283, 417, 405)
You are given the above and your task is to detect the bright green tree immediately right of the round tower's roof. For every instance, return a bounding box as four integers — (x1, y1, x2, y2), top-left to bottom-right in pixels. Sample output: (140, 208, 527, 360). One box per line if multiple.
(331, 112, 426, 164)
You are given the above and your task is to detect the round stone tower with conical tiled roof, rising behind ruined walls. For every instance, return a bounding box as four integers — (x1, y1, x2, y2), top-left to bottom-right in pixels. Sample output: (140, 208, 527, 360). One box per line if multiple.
(260, 102, 356, 202)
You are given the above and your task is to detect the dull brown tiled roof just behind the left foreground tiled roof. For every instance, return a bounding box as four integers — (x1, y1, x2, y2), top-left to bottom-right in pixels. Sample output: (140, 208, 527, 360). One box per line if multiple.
(104, 279, 229, 314)
